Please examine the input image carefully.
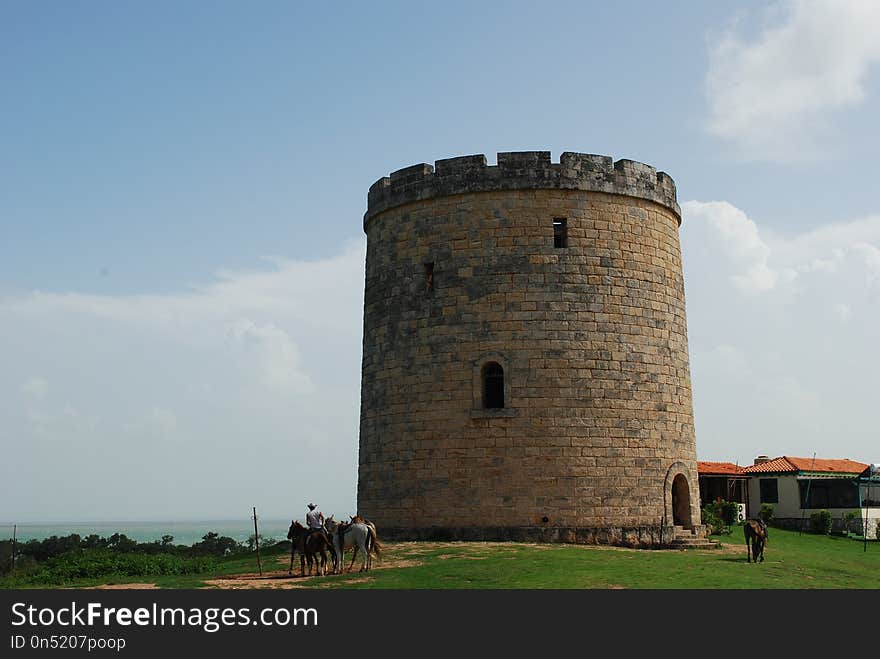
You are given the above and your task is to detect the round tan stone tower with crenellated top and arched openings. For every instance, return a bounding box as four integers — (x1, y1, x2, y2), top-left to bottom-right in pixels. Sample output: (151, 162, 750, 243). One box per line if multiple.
(358, 151, 700, 546)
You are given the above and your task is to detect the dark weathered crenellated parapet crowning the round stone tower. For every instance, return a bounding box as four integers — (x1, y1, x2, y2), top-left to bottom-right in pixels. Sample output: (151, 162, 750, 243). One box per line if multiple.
(364, 151, 681, 228)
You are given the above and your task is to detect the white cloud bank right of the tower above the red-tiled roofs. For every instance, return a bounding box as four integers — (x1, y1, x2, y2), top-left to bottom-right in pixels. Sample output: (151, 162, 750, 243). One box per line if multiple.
(681, 202, 880, 464)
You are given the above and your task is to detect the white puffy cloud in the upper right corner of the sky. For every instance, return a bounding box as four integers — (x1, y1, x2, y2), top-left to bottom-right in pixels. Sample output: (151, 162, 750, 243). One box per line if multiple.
(706, 0, 880, 161)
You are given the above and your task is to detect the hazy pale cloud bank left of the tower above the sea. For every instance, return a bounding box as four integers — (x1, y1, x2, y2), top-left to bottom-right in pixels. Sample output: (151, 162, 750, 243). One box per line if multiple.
(0, 241, 365, 519)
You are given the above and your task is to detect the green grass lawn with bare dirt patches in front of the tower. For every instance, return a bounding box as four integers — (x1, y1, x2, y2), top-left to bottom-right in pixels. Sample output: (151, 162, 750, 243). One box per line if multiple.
(3, 528, 880, 589)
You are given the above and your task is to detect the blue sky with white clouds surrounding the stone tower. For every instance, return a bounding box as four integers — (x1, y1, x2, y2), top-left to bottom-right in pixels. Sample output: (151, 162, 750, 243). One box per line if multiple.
(0, 1, 880, 521)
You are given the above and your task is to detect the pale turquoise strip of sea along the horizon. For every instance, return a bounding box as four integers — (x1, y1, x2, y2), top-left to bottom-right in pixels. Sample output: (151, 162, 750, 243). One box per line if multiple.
(0, 518, 290, 545)
